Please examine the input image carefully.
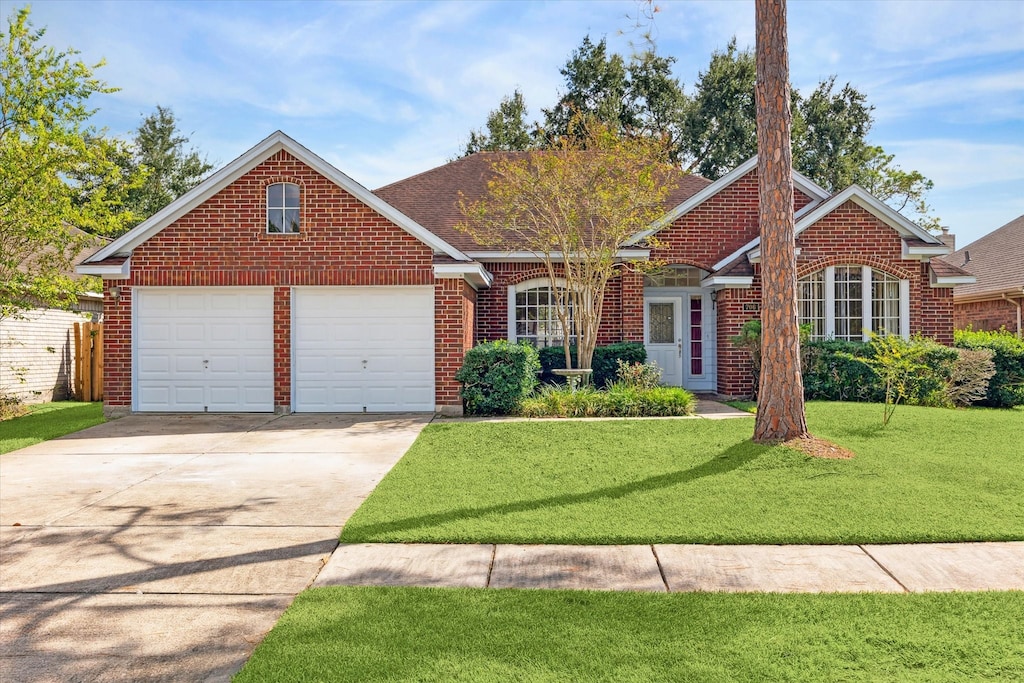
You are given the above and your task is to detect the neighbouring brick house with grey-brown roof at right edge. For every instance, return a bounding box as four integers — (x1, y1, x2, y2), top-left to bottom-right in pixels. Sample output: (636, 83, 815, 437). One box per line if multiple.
(942, 216, 1024, 337)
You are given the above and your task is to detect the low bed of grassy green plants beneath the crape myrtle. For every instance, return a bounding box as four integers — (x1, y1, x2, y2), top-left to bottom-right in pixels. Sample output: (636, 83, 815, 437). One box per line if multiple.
(520, 384, 696, 418)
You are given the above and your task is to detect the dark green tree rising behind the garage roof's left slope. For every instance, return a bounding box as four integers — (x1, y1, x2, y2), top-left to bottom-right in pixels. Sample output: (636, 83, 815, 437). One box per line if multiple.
(128, 104, 213, 227)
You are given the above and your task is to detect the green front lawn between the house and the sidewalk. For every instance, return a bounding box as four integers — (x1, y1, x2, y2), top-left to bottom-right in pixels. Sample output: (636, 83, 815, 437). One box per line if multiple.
(341, 403, 1024, 544)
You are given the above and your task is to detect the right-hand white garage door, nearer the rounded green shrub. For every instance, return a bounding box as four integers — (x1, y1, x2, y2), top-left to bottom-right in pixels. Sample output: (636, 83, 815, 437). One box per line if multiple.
(292, 287, 434, 413)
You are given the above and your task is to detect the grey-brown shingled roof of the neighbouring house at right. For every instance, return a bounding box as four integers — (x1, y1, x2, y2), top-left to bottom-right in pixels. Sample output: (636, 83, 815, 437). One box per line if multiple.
(942, 216, 1024, 299)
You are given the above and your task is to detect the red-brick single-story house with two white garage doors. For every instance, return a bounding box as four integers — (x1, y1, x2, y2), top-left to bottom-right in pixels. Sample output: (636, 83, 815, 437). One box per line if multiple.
(79, 132, 970, 414)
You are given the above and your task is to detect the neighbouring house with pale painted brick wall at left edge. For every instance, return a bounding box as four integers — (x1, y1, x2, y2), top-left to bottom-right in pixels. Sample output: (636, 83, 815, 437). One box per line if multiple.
(0, 237, 108, 403)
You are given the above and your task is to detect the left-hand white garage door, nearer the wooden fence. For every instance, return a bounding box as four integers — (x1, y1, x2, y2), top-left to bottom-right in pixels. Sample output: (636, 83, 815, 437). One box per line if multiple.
(134, 287, 273, 413)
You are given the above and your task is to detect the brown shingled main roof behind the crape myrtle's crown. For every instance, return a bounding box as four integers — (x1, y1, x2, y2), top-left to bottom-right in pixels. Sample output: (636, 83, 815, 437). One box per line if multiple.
(374, 152, 711, 251)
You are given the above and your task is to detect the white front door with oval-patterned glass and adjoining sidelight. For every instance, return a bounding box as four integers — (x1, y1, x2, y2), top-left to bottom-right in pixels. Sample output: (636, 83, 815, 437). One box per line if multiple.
(644, 291, 716, 391)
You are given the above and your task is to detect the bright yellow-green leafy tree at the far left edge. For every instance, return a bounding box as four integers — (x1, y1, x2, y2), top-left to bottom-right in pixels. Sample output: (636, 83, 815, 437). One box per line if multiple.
(0, 8, 132, 317)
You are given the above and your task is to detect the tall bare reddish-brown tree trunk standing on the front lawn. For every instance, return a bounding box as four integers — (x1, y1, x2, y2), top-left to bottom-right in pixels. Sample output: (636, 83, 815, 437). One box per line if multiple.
(754, 0, 807, 443)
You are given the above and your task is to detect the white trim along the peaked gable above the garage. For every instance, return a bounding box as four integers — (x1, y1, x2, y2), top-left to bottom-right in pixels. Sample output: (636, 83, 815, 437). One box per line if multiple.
(84, 130, 470, 263)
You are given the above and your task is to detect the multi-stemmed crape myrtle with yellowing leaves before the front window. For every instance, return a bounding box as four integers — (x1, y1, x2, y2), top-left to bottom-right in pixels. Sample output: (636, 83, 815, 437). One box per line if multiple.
(457, 114, 672, 370)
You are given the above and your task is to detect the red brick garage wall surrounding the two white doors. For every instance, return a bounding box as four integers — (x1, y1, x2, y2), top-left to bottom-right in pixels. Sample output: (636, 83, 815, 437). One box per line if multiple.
(104, 152, 465, 407)
